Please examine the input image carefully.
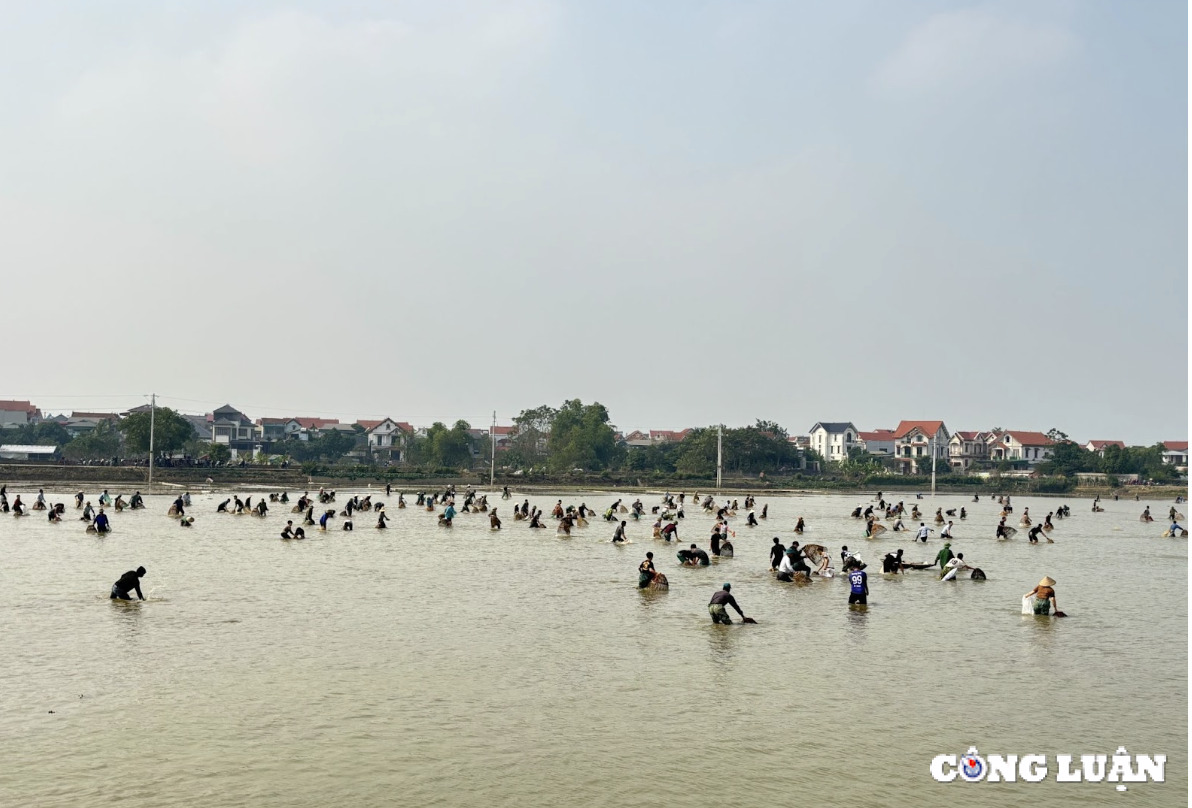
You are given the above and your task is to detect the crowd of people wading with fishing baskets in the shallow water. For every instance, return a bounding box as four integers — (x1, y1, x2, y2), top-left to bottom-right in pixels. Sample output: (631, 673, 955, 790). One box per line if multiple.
(0, 485, 1187, 623)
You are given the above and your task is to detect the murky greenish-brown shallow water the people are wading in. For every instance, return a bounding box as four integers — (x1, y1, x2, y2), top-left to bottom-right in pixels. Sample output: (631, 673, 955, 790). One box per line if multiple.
(0, 486, 1188, 808)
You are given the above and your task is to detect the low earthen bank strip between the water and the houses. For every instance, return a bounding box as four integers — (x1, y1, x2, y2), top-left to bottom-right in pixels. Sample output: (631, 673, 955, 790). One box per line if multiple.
(0, 464, 1188, 501)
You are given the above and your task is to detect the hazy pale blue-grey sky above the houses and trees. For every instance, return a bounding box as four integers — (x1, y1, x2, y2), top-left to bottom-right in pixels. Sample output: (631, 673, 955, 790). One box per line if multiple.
(0, 0, 1188, 443)
